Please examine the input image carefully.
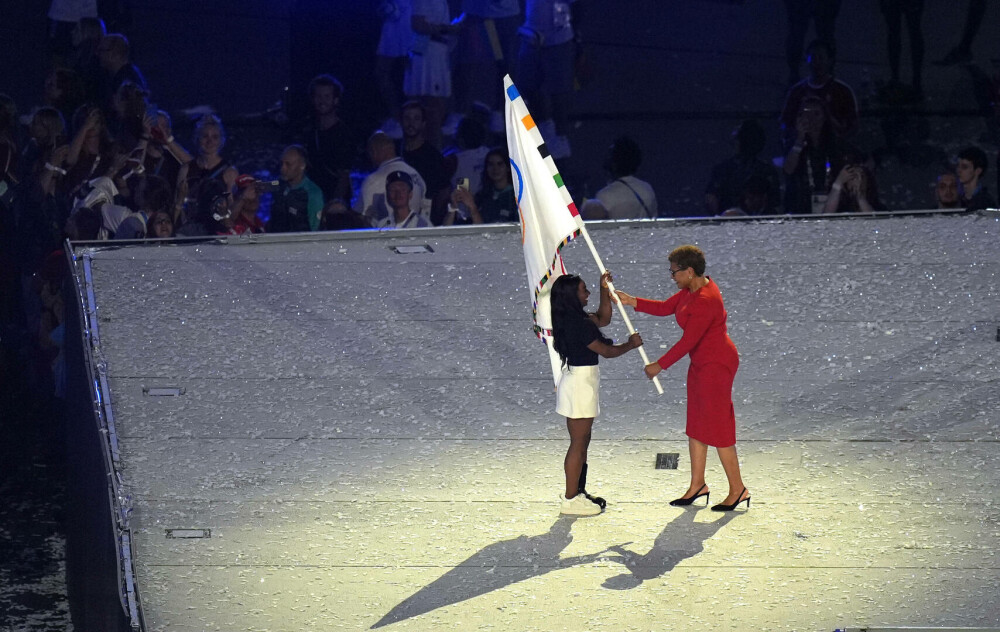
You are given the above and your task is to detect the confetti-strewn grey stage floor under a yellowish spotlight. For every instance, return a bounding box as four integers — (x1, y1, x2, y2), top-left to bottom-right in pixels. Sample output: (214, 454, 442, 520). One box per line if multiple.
(75, 214, 1000, 632)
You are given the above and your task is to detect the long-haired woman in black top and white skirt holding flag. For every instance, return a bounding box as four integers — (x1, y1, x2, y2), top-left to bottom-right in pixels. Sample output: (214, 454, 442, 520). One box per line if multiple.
(550, 272, 642, 516)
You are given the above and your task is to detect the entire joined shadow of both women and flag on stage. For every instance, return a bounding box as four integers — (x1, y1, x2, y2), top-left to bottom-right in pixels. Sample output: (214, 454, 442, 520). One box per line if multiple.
(371, 509, 736, 629)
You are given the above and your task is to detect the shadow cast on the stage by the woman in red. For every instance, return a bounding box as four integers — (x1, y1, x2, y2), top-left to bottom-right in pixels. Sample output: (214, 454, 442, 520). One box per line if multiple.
(602, 509, 736, 590)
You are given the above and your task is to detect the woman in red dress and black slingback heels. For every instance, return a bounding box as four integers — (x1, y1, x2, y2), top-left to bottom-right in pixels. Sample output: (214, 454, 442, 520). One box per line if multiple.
(617, 246, 750, 511)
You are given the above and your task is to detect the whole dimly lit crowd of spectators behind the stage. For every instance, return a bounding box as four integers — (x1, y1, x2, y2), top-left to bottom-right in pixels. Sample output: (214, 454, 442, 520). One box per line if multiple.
(0, 0, 1000, 396)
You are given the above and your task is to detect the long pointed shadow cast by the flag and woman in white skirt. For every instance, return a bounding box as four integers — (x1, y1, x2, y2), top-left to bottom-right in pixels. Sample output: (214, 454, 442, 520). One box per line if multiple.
(371, 516, 607, 629)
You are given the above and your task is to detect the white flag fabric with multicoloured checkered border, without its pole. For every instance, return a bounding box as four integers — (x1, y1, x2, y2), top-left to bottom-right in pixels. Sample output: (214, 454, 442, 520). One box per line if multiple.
(504, 75, 583, 385)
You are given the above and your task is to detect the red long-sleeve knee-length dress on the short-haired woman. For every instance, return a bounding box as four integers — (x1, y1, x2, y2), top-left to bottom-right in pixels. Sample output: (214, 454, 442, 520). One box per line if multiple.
(635, 279, 740, 448)
